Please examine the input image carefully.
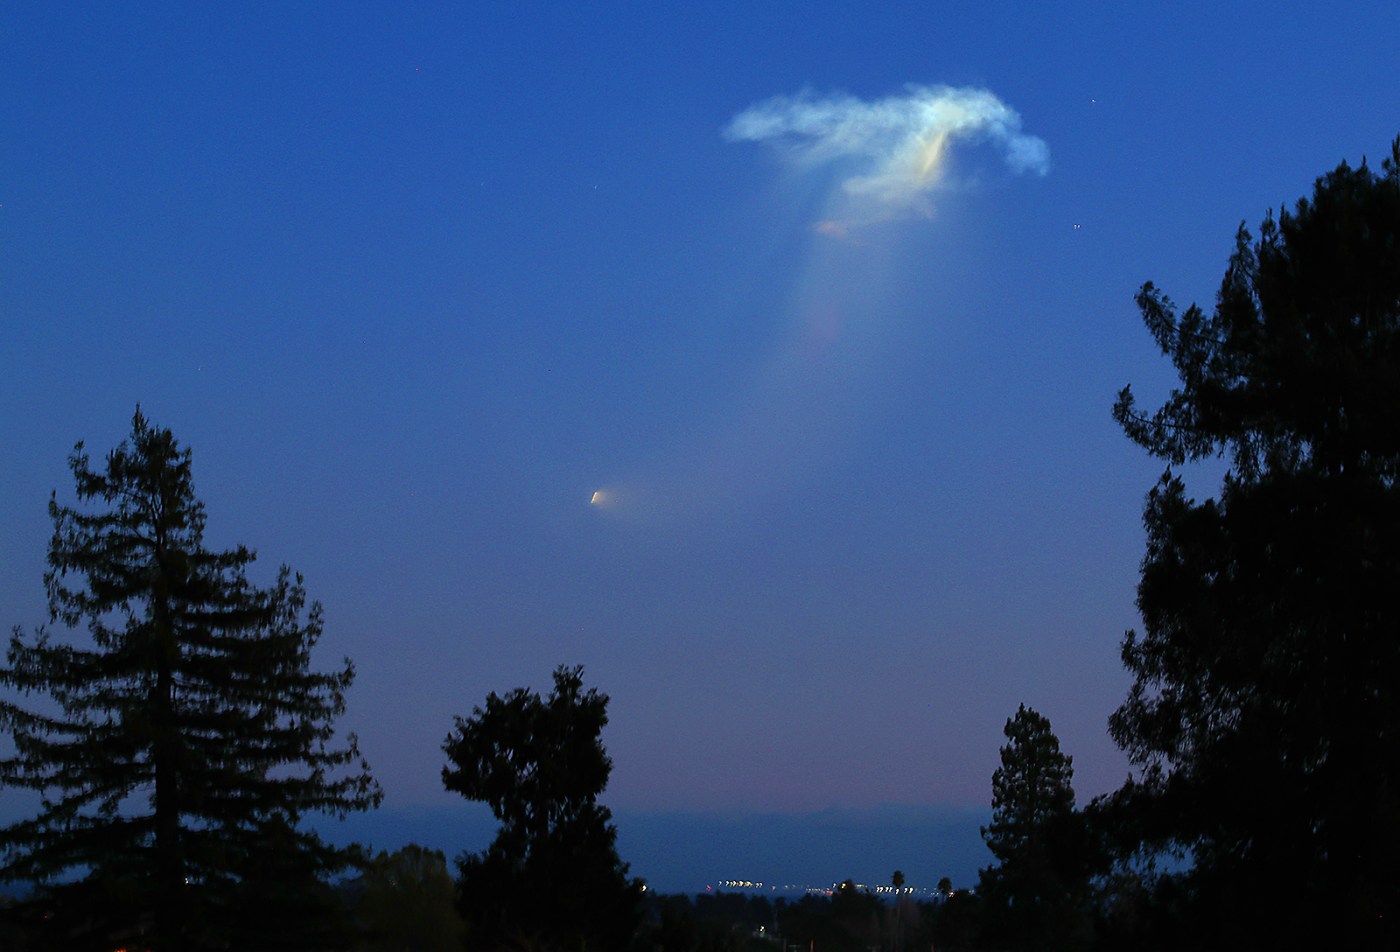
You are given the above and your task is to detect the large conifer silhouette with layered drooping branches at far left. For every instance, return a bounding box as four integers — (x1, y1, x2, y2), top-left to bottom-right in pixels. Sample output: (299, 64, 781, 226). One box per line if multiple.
(0, 410, 379, 952)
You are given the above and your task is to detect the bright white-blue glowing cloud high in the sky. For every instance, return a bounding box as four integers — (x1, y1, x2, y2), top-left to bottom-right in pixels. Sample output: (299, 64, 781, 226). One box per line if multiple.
(724, 85, 1050, 219)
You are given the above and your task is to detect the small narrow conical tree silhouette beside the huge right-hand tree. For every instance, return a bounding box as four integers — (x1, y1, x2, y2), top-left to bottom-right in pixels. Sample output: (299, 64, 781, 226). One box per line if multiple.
(979, 704, 1092, 949)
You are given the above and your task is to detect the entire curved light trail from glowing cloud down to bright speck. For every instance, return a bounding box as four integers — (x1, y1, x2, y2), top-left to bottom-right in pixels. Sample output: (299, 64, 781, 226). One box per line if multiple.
(591, 85, 1050, 524)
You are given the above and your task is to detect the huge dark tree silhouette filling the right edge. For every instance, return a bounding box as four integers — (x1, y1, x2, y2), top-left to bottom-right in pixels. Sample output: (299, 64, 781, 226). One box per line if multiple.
(1109, 139, 1400, 948)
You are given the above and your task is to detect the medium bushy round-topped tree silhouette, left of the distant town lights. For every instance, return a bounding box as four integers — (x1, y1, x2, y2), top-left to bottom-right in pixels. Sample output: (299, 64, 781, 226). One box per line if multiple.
(442, 666, 641, 952)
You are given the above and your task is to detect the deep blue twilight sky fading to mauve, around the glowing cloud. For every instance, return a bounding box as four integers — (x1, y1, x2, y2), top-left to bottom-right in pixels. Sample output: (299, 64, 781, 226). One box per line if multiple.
(0, 0, 1400, 879)
